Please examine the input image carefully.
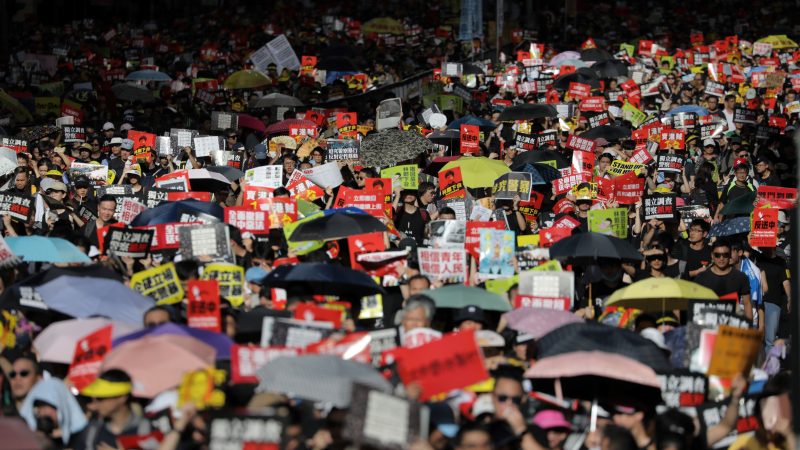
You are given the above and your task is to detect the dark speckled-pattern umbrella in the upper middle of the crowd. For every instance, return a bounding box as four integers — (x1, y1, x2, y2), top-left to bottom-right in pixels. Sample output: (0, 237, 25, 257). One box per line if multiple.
(361, 128, 434, 167)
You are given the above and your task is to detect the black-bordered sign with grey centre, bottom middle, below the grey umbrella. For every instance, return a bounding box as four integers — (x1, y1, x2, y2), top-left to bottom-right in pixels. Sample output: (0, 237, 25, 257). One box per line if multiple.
(344, 383, 428, 449)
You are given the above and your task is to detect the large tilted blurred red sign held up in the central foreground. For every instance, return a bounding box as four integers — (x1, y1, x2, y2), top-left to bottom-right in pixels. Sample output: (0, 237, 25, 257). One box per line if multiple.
(397, 330, 489, 401)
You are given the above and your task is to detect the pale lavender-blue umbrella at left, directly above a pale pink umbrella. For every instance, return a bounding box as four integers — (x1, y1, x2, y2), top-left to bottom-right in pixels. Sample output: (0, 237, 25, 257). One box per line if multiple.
(37, 275, 155, 325)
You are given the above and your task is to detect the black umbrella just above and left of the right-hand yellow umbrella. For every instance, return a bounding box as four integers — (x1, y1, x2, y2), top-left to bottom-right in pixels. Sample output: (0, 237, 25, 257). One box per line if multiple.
(550, 233, 642, 265)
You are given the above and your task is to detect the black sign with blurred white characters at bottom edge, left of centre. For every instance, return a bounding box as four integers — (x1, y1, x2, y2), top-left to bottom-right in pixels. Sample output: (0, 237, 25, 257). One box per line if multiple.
(208, 410, 285, 450)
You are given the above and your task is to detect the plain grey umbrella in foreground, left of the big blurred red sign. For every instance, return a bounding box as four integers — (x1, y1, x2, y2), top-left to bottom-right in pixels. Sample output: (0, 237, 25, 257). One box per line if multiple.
(256, 355, 392, 408)
